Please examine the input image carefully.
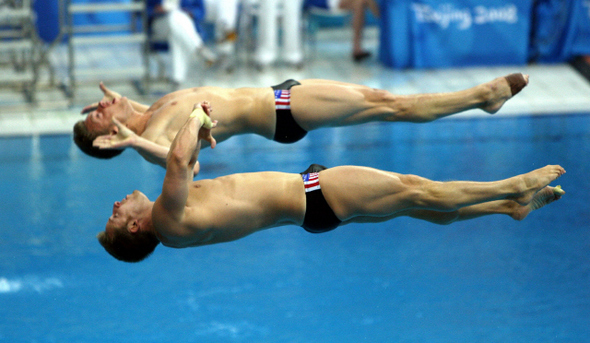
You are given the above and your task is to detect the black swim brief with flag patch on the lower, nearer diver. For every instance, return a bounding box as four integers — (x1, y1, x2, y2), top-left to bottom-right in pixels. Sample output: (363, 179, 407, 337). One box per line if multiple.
(300, 164, 342, 233)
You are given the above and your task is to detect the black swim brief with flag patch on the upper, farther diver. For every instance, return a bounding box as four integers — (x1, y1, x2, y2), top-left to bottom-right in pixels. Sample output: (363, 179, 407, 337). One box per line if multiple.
(272, 80, 307, 143)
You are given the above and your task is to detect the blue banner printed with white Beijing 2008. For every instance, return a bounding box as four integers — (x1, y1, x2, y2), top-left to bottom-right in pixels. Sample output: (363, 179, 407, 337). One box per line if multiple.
(380, 0, 532, 68)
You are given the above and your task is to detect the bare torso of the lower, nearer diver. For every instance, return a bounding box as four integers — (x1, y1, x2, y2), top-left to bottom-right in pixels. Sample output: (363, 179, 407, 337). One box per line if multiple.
(153, 172, 306, 248)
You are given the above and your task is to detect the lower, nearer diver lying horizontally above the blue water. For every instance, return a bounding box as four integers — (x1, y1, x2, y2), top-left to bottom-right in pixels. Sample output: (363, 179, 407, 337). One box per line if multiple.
(97, 103, 565, 262)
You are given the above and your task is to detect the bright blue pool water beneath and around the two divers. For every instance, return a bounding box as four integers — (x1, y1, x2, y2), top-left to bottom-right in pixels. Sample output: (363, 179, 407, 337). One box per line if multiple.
(0, 114, 590, 343)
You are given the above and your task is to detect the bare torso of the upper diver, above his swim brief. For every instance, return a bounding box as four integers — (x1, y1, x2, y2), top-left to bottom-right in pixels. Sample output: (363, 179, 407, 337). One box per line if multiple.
(139, 87, 276, 147)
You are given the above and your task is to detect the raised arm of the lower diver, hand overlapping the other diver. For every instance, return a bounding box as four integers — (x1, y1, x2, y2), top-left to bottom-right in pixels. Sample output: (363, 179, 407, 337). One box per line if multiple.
(155, 102, 217, 222)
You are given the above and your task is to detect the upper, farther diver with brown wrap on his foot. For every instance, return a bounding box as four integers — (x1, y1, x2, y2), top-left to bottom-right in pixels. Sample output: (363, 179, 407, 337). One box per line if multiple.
(74, 73, 528, 171)
